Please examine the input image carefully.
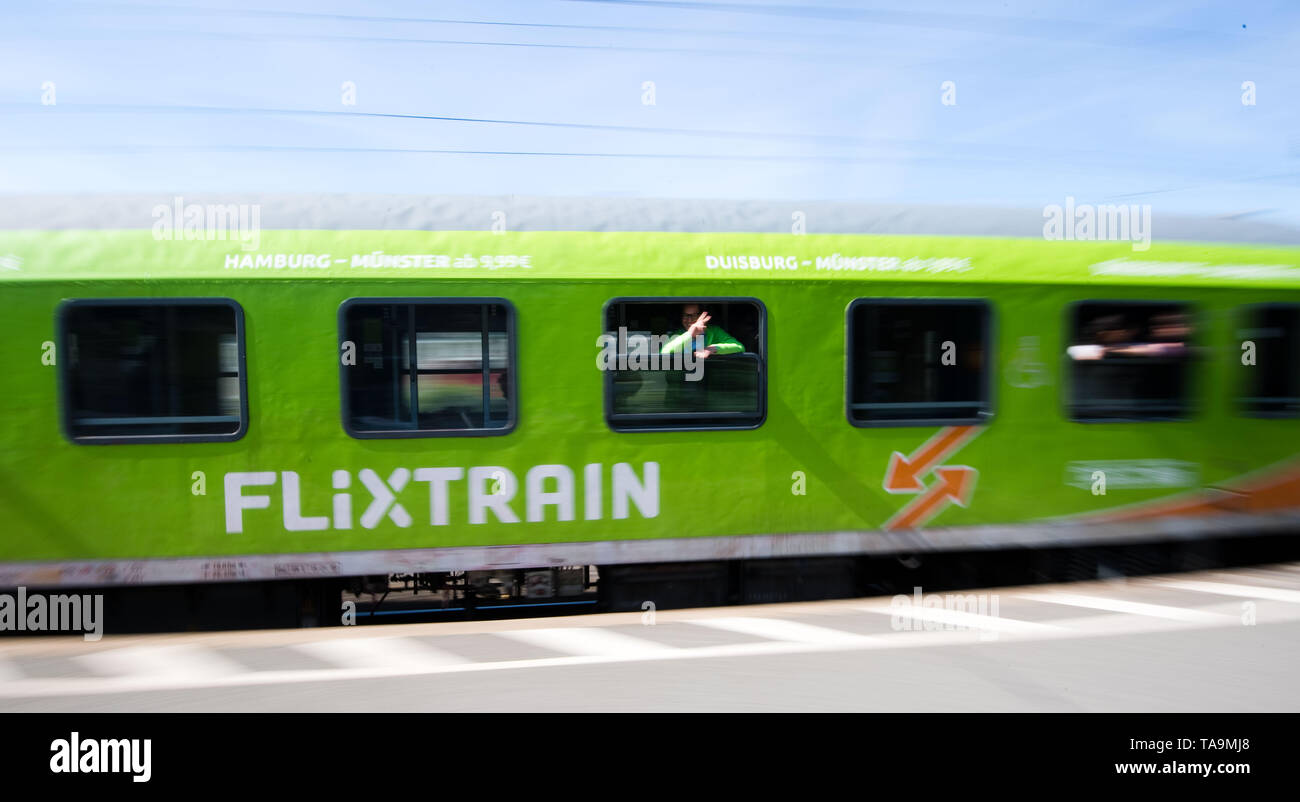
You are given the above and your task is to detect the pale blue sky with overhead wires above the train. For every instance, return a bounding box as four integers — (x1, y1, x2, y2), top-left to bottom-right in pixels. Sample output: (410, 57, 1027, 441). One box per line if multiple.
(0, 0, 1300, 226)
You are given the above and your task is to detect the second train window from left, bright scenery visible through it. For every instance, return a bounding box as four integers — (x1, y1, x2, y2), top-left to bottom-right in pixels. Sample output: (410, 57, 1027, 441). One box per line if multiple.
(339, 298, 516, 438)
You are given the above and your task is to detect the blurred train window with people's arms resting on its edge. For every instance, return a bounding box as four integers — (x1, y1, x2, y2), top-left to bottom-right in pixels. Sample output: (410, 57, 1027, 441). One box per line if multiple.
(1065, 300, 1195, 421)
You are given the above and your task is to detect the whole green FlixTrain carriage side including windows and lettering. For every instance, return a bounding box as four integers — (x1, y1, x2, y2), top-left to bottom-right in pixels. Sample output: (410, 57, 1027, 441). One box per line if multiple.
(0, 194, 1300, 613)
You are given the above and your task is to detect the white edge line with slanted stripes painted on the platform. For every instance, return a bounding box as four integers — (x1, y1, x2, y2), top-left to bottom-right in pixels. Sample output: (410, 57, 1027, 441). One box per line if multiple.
(0, 566, 1300, 699)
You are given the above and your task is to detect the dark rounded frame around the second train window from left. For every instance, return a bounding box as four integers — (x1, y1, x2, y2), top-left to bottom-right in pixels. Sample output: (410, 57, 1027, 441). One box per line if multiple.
(334, 295, 519, 439)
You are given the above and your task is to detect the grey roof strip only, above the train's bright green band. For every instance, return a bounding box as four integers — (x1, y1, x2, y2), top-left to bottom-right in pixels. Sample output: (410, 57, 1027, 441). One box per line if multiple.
(0, 192, 1300, 246)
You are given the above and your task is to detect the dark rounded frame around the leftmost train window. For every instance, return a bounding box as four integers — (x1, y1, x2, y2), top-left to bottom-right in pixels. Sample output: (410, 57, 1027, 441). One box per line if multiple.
(55, 296, 250, 446)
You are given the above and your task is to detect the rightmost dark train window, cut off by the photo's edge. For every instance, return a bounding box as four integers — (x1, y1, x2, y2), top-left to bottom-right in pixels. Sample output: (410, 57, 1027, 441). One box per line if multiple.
(1232, 304, 1300, 417)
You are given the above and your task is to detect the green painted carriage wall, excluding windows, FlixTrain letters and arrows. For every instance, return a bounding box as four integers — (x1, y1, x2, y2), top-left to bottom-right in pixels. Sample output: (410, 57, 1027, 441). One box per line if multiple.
(0, 230, 1300, 563)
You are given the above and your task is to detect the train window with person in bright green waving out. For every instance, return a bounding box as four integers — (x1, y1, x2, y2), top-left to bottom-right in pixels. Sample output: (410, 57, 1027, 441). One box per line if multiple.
(597, 298, 767, 432)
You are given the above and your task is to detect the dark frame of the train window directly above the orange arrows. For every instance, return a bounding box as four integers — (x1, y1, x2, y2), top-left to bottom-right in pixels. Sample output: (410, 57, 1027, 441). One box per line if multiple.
(844, 295, 997, 429)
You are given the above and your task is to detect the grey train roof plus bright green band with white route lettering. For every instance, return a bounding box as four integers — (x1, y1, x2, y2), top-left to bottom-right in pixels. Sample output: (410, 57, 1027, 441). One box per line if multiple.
(0, 194, 1300, 289)
